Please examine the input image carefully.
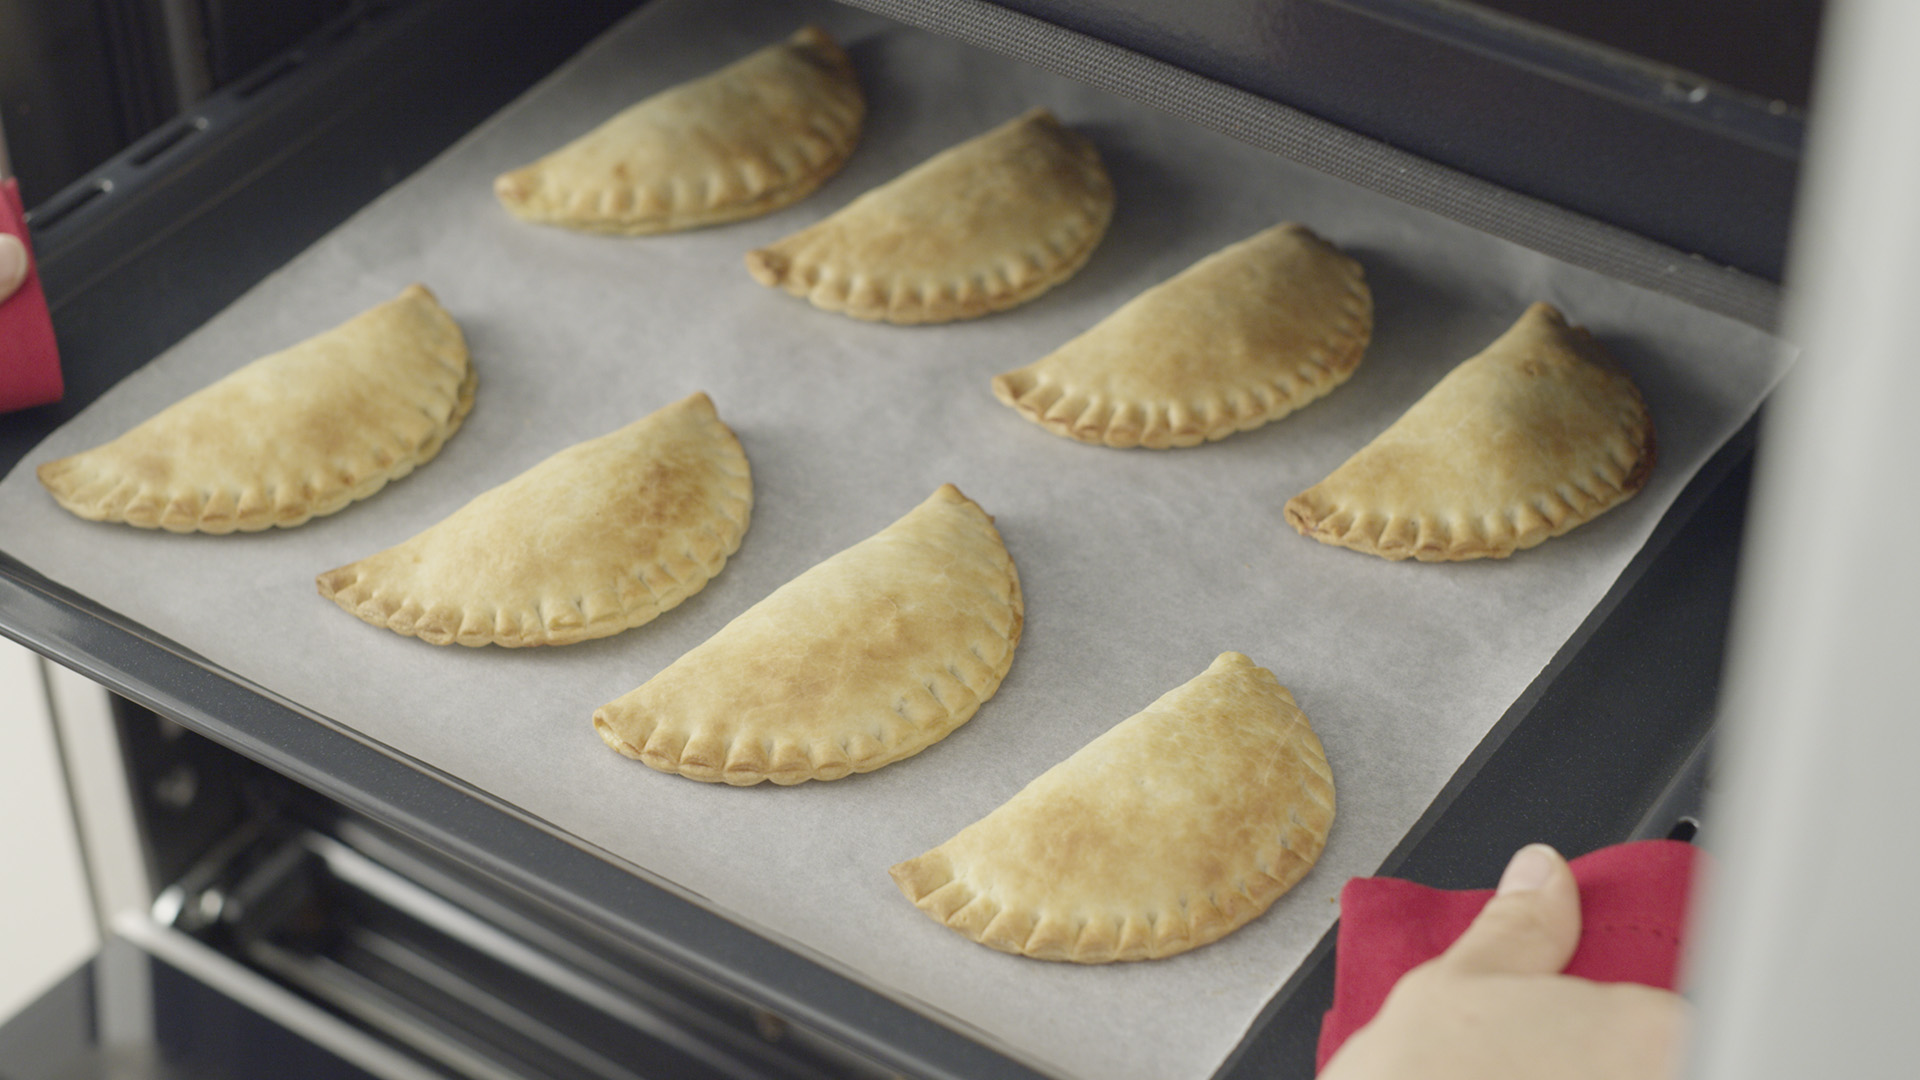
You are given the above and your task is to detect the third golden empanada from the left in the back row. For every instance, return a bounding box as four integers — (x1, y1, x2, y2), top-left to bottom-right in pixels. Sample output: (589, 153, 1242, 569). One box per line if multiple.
(993, 223, 1373, 450)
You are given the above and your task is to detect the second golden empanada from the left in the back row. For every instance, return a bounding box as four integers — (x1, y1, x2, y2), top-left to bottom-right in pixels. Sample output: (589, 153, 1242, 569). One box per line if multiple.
(747, 110, 1114, 323)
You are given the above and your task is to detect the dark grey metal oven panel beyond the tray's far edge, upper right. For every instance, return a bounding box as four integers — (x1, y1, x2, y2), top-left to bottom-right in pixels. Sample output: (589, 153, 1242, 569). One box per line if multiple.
(1004, 0, 1801, 281)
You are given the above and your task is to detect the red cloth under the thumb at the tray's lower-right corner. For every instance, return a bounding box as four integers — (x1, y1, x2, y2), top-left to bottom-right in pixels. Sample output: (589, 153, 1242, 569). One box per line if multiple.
(1317, 840, 1697, 1068)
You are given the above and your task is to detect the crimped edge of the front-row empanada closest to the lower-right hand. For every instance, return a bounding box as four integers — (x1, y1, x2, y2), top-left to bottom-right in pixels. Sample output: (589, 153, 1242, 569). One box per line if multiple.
(887, 651, 1334, 965)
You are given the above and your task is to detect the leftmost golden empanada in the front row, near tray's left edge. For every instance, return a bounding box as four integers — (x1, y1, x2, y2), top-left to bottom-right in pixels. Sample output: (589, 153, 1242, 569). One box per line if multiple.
(38, 284, 474, 532)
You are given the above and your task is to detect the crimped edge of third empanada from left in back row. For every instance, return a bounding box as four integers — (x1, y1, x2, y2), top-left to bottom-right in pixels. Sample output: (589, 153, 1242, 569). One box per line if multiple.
(993, 225, 1373, 450)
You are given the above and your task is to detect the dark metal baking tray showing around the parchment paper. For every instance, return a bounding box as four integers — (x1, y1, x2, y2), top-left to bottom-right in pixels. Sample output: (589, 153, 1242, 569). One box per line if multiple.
(0, 0, 1745, 1078)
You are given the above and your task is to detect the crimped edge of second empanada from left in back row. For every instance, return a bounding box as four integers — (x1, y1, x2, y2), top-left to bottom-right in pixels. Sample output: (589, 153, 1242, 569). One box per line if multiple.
(747, 108, 1114, 327)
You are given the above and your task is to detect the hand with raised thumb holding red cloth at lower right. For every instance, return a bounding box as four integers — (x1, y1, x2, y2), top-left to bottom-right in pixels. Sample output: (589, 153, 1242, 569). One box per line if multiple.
(1321, 844, 1690, 1080)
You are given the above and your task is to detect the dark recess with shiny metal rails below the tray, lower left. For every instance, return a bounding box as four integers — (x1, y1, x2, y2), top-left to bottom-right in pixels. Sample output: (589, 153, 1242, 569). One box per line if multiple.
(156, 814, 891, 1080)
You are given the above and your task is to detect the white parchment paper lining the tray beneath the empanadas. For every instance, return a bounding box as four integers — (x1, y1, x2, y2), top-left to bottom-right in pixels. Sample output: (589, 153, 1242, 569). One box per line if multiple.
(0, 0, 1786, 1078)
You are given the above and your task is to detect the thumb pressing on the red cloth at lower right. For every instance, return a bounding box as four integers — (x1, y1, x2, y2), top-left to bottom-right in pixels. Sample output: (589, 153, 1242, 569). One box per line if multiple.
(1436, 844, 1580, 974)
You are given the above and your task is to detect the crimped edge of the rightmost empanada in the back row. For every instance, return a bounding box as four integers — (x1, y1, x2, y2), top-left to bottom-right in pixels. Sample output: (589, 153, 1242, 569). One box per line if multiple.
(1284, 304, 1659, 563)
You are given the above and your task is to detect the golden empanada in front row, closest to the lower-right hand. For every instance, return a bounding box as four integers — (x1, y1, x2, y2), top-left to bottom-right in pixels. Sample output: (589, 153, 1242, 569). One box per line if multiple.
(891, 653, 1332, 963)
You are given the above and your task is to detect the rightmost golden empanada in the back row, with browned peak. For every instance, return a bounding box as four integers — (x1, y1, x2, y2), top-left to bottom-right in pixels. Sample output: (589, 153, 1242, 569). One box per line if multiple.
(1286, 304, 1653, 563)
